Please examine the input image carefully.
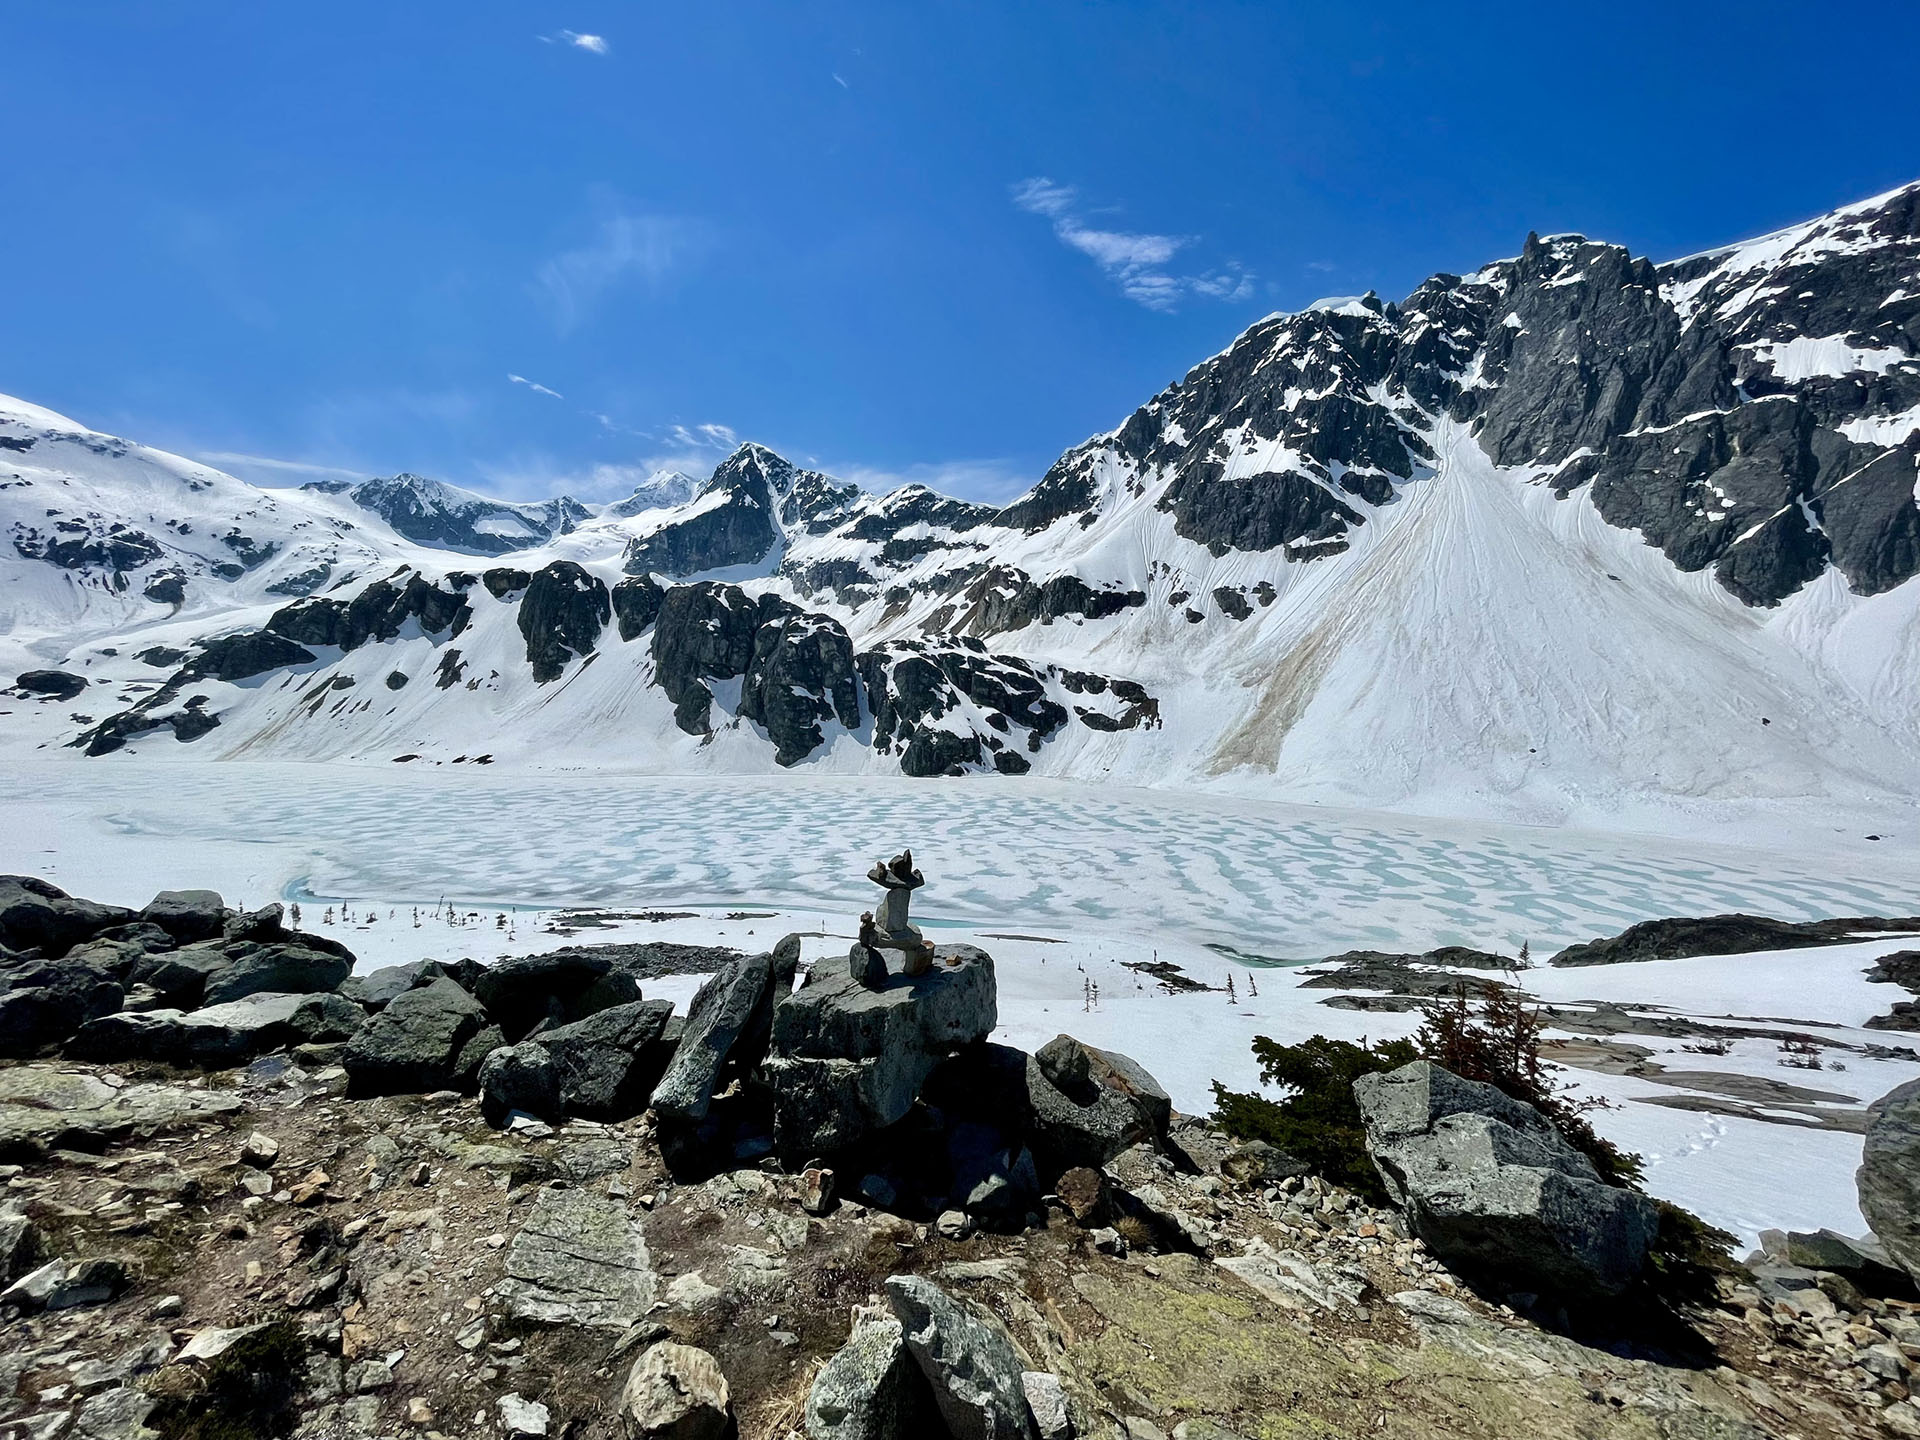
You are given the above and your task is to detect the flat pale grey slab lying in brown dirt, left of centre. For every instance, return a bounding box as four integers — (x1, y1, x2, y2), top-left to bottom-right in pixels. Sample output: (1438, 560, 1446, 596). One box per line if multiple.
(501, 1190, 659, 1331)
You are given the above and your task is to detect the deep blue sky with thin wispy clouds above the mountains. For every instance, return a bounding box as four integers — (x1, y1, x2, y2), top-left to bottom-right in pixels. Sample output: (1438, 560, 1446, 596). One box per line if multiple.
(0, 0, 1920, 499)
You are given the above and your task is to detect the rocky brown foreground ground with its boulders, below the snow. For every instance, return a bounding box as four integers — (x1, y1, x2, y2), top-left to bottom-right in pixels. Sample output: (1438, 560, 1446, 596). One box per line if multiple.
(0, 881, 1920, 1440)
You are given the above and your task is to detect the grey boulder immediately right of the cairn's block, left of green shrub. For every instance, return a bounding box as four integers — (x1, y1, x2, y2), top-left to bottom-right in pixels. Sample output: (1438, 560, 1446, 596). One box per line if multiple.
(1027, 1035, 1173, 1177)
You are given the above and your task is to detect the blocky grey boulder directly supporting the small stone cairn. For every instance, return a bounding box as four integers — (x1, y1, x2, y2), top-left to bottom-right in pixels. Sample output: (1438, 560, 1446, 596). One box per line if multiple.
(760, 945, 998, 1156)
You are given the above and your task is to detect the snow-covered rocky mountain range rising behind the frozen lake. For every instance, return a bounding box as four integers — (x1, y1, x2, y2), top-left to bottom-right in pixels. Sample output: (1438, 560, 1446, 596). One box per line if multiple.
(0, 184, 1920, 833)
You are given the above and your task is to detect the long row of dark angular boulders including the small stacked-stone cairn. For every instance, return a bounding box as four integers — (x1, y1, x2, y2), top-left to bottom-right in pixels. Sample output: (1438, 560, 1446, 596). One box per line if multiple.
(0, 867, 1171, 1235)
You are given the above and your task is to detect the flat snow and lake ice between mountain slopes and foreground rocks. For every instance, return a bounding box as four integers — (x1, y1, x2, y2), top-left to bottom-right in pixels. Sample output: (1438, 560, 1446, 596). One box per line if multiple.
(0, 758, 1920, 1242)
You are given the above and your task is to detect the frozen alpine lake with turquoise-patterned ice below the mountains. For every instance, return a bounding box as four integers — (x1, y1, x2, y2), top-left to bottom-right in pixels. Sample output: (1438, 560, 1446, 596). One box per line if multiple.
(0, 760, 1920, 960)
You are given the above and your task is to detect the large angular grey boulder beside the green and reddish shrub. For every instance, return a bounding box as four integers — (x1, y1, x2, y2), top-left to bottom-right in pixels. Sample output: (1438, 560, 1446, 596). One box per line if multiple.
(1354, 1060, 1659, 1298)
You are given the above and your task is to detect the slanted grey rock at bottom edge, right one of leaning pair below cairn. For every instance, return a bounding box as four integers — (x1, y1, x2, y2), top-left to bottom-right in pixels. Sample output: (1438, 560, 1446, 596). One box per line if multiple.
(887, 1275, 1033, 1440)
